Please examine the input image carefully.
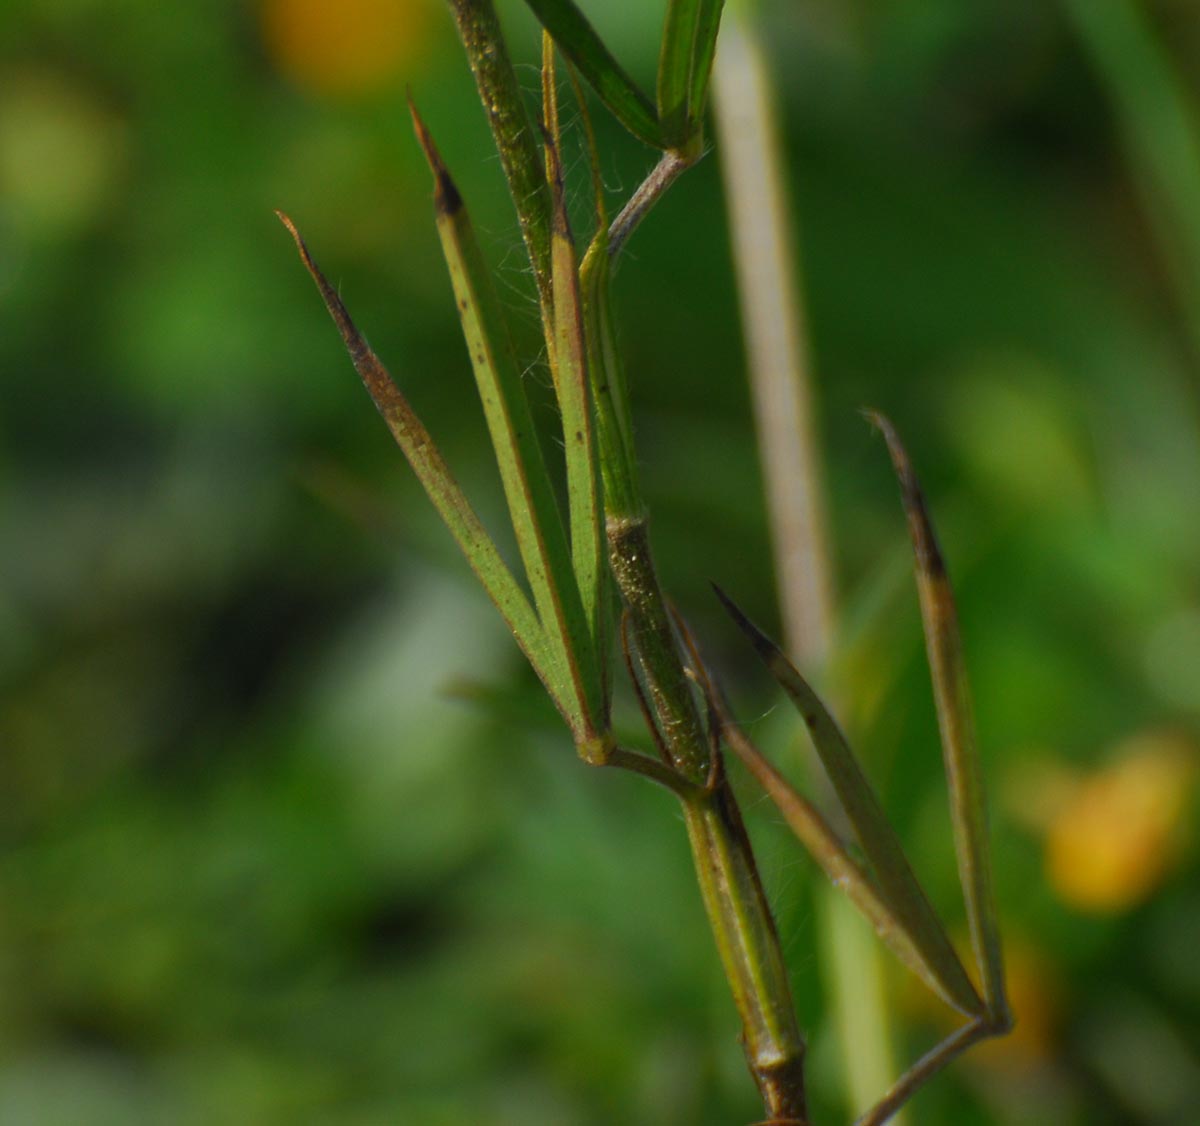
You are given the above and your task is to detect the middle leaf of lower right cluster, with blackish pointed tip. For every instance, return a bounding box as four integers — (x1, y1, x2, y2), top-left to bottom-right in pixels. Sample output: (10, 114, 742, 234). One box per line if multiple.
(714, 587, 982, 1014)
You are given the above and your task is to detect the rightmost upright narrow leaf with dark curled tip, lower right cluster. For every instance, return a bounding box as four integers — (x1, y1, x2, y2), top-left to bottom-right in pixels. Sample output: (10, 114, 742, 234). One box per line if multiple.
(868, 412, 1008, 1019)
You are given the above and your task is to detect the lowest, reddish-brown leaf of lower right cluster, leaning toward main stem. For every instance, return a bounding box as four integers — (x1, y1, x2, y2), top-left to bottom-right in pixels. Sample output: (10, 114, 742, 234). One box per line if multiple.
(724, 720, 980, 1014)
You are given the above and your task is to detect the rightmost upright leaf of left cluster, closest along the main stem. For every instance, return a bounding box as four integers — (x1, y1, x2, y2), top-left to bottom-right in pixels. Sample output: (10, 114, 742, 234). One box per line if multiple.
(546, 83, 610, 702)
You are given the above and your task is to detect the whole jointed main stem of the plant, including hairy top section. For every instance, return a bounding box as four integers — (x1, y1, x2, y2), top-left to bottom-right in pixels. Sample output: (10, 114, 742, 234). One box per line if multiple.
(451, 10, 806, 1126)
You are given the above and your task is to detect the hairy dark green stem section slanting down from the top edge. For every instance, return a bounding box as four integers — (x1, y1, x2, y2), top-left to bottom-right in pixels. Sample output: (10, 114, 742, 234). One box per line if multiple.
(450, 0, 554, 319)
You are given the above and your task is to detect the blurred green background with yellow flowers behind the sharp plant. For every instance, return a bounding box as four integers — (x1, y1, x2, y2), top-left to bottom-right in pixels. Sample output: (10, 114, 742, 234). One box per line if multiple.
(0, 0, 1200, 1126)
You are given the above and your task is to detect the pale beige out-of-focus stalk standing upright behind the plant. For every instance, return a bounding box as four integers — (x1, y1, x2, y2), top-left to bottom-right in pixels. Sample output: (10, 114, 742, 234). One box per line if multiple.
(713, 2, 900, 1121)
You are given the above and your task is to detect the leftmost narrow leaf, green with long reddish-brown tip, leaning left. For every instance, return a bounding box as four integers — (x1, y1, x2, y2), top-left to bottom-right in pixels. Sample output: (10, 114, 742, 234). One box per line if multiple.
(277, 212, 556, 709)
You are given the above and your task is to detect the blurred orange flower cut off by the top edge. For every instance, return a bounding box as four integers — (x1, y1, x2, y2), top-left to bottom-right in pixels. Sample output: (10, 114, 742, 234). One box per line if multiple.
(262, 0, 436, 95)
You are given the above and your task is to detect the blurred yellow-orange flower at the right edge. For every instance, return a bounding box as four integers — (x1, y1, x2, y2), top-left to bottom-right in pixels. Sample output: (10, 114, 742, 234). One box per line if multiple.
(1045, 732, 1196, 914)
